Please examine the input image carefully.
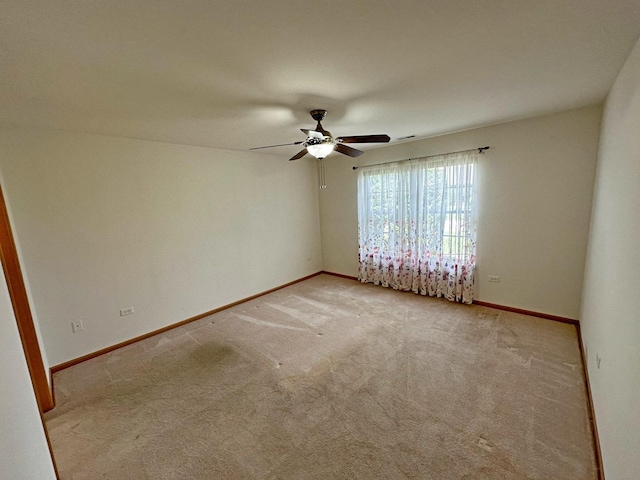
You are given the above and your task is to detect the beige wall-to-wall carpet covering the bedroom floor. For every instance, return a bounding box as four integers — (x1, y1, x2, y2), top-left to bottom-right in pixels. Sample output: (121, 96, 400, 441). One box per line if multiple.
(46, 275, 597, 480)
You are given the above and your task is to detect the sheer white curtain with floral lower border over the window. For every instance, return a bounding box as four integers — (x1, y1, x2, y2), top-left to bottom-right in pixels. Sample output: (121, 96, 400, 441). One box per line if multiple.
(358, 152, 478, 303)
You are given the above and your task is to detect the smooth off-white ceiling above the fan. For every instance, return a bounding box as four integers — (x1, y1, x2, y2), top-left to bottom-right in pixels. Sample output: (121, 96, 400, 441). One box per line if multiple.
(0, 0, 640, 156)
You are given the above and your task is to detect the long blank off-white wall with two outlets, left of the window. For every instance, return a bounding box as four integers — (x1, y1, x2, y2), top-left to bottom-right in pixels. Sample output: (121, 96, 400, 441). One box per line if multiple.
(0, 129, 321, 365)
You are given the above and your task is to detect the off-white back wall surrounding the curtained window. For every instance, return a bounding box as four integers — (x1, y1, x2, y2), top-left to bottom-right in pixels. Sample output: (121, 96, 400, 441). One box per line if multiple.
(320, 106, 601, 318)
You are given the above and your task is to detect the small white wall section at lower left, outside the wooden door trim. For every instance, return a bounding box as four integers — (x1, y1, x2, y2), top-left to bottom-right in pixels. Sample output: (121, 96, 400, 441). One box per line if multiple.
(0, 269, 56, 480)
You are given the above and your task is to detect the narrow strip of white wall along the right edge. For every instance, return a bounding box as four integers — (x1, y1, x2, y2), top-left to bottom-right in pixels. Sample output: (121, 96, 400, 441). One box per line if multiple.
(581, 35, 640, 480)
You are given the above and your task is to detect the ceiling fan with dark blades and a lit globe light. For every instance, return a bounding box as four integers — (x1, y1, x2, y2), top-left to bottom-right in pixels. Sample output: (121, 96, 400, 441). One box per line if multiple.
(249, 110, 390, 161)
